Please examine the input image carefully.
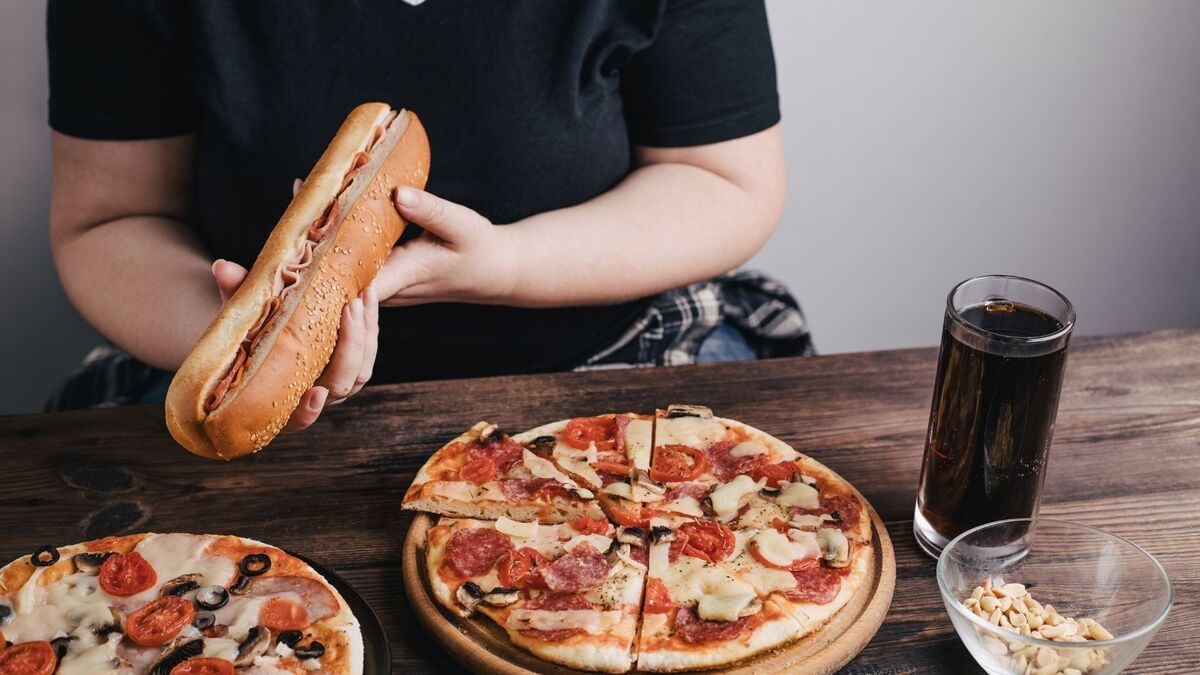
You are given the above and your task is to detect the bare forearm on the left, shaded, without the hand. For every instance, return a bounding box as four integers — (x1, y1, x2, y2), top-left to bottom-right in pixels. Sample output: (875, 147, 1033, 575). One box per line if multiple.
(54, 216, 221, 370)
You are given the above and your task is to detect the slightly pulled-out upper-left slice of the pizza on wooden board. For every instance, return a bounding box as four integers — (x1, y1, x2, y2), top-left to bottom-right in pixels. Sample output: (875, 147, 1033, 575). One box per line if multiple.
(402, 422, 604, 522)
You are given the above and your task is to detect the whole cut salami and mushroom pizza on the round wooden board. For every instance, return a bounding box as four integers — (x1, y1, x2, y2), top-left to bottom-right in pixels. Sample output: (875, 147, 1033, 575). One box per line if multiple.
(403, 405, 875, 673)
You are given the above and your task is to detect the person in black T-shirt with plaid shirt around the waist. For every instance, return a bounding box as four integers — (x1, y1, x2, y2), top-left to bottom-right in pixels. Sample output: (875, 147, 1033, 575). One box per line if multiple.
(47, 0, 811, 429)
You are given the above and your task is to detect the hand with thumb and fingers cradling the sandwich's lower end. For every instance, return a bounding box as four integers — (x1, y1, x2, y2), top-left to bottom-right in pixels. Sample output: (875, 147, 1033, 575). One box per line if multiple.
(212, 261, 379, 431)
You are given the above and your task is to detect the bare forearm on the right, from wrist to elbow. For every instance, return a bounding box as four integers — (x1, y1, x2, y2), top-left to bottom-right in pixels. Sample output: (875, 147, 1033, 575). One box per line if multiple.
(505, 158, 778, 306)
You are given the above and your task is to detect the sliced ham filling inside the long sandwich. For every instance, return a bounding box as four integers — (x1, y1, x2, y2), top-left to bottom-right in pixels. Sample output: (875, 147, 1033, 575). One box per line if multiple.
(204, 113, 397, 412)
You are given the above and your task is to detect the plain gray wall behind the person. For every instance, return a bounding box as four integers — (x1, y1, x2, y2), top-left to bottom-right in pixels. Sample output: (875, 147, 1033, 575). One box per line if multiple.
(0, 0, 1200, 413)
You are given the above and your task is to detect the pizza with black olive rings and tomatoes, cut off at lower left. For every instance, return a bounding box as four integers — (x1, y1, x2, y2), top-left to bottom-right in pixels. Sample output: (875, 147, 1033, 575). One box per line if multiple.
(0, 533, 364, 675)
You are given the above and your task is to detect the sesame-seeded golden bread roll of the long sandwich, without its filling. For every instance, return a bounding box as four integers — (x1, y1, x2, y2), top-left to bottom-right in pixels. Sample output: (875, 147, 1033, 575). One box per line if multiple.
(166, 103, 430, 460)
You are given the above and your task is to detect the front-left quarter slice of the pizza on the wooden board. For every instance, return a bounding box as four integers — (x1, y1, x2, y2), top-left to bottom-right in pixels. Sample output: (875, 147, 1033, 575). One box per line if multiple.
(426, 518, 646, 673)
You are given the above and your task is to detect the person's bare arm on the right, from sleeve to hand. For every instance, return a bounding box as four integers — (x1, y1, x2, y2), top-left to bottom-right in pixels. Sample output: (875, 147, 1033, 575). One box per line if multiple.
(376, 125, 786, 307)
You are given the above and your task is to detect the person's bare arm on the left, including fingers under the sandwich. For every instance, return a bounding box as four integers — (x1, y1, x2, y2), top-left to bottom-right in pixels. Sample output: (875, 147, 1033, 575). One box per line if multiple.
(50, 132, 379, 430)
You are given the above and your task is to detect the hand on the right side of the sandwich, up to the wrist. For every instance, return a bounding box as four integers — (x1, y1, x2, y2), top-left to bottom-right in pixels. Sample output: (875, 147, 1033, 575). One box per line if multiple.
(374, 187, 520, 306)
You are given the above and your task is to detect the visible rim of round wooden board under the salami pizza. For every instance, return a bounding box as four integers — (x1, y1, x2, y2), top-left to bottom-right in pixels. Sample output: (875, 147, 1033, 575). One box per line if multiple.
(403, 500, 896, 675)
